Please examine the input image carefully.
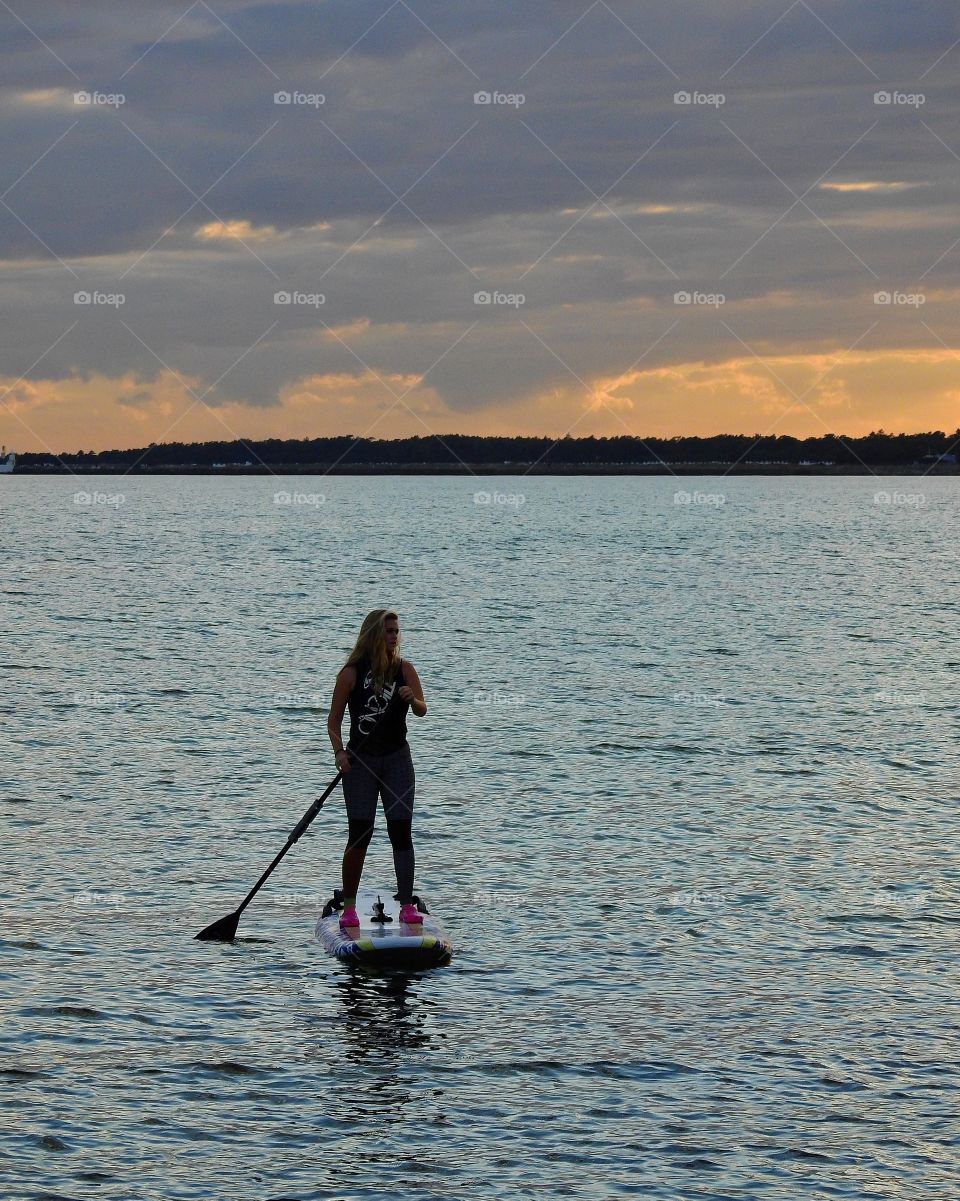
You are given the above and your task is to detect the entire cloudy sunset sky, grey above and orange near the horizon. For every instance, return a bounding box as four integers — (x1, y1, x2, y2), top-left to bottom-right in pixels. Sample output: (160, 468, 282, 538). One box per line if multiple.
(0, 0, 960, 453)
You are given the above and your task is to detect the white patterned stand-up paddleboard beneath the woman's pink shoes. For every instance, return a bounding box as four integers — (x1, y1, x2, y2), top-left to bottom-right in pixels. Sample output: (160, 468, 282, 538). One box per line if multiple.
(316, 889, 453, 968)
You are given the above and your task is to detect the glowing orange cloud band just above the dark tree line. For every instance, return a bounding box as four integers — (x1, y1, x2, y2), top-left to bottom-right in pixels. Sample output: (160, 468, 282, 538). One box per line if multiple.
(2, 349, 960, 453)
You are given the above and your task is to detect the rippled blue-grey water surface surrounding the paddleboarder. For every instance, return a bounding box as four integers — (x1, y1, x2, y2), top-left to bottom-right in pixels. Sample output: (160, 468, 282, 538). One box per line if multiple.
(0, 476, 960, 1201)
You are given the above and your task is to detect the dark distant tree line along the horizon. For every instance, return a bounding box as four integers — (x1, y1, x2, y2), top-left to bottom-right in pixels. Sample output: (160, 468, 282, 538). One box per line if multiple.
(17, 429, 960, 472)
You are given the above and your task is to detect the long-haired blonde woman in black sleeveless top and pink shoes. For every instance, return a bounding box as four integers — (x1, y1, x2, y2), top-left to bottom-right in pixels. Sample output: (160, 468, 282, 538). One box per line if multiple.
(327, 609, 427, 926)
